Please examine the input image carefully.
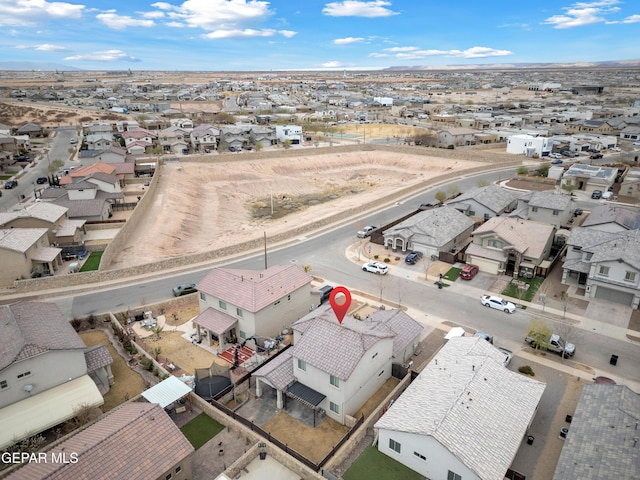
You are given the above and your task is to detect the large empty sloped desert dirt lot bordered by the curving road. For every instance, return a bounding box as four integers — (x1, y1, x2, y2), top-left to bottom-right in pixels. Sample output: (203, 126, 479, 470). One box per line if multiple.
(110, 151, 482, 268)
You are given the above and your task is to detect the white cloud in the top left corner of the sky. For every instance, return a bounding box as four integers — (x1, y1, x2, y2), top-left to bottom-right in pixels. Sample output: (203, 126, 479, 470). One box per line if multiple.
(0, 0, 85, 27)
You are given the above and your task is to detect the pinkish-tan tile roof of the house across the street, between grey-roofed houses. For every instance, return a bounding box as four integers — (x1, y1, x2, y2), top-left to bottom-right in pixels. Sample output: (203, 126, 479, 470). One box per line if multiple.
(473, 216, 555, 258)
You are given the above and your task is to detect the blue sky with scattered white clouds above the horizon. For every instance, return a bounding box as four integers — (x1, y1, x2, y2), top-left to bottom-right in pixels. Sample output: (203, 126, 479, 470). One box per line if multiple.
(0, 0, 640, 71)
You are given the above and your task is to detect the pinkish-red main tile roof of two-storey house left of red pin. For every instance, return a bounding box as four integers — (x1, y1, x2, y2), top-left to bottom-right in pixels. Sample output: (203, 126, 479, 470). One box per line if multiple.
(198, 265, 311, 313)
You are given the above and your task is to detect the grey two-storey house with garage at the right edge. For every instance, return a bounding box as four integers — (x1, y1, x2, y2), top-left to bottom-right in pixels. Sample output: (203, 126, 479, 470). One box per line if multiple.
(562, 227, 640, 309)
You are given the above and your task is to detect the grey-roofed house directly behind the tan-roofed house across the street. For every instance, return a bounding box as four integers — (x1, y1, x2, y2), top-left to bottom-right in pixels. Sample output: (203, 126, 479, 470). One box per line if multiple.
(509, 191, 574, 229)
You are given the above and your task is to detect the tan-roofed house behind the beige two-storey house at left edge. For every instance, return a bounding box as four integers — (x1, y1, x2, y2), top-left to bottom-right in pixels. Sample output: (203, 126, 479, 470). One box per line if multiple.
(0, 202, 86, 246)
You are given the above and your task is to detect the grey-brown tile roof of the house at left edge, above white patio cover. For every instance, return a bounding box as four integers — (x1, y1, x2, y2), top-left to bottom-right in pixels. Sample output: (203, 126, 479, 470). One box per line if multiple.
(0, 302, 86, 371)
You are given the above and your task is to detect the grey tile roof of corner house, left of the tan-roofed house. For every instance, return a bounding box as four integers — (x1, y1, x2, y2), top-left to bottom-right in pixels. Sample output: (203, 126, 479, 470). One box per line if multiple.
(384, 206, 473, 247)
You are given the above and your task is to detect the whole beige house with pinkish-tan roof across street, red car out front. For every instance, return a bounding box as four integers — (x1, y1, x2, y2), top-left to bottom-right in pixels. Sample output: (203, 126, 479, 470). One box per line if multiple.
(466, 216, 556, 278)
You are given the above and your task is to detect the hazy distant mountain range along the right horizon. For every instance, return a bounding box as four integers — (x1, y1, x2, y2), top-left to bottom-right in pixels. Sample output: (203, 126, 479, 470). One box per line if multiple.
(384, 59, 640, 71)
